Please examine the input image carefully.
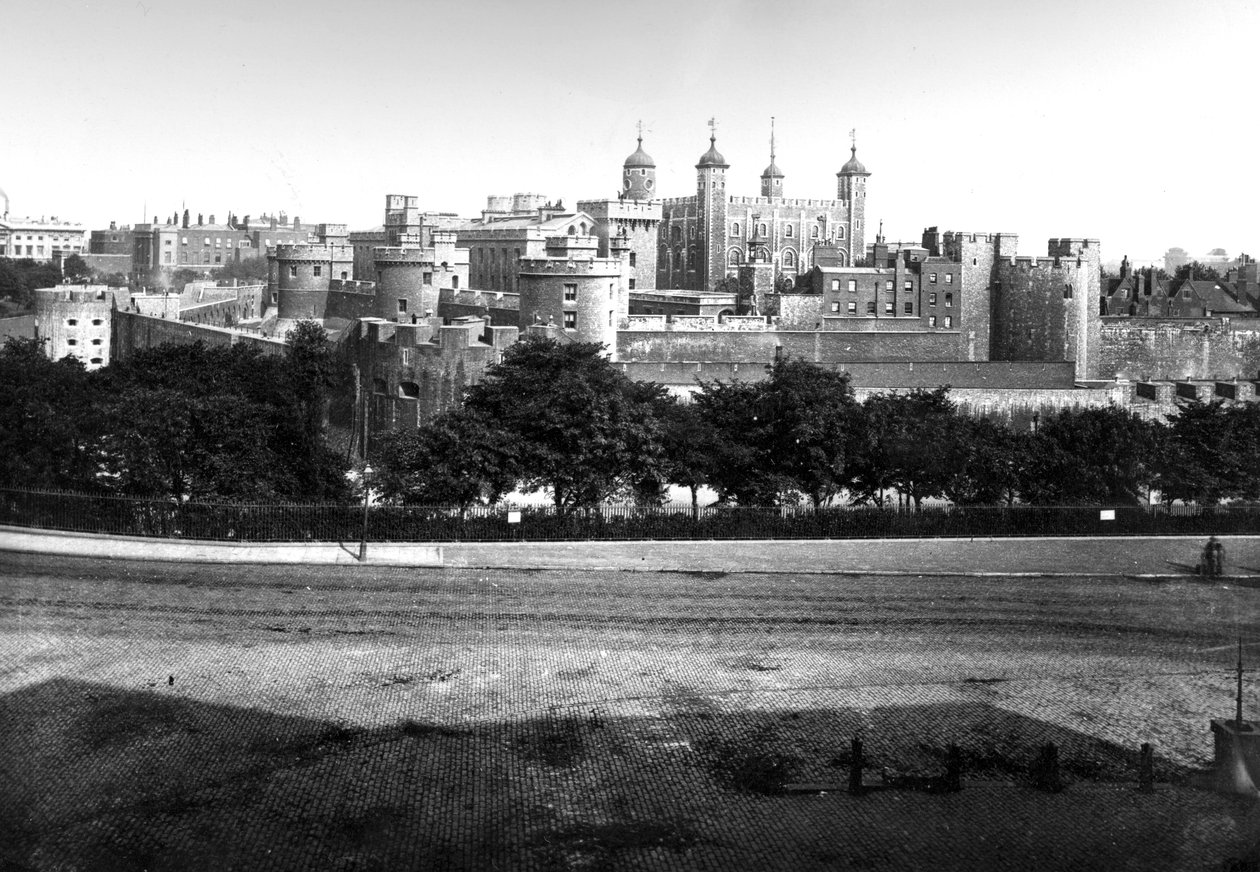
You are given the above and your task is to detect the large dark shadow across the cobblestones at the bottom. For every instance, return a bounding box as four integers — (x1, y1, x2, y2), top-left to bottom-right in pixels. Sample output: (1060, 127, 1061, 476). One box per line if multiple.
(0, 679, 1257, 869)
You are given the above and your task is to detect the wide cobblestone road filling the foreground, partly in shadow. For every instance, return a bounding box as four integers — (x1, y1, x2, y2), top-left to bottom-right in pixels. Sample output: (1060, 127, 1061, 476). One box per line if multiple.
(0, 554, 1260, 869)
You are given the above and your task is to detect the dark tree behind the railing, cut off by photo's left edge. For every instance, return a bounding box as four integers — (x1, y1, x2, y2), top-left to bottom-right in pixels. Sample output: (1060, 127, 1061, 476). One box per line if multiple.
(0, 338, 97, 489)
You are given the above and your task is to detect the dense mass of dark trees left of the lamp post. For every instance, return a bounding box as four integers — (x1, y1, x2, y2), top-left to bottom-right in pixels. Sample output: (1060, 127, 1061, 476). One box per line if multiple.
(0, 323, 349, 502)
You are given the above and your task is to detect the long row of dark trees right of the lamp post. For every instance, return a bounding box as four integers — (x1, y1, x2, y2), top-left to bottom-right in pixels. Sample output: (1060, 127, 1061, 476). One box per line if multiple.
(374, 339, 1260, 512)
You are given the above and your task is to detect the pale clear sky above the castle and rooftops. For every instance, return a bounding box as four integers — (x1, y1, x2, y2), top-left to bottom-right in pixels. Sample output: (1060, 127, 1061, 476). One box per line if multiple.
(0, 0, 1260, 262)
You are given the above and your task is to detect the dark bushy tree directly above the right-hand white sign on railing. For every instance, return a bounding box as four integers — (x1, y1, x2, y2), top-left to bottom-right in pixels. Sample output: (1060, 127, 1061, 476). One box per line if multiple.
(1022, 406, 1166, 505)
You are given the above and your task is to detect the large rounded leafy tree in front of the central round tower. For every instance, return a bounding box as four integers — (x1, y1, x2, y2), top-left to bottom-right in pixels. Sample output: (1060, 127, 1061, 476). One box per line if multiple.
(465, 338, 662, 513)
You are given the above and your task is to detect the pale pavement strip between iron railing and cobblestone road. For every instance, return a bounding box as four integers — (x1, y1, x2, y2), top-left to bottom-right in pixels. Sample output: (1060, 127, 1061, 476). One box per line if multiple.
(0, 527, 1260, 578)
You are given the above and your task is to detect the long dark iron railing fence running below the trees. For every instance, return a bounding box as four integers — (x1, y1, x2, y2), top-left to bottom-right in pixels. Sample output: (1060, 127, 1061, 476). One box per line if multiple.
(0, 490, 1260, 542)
